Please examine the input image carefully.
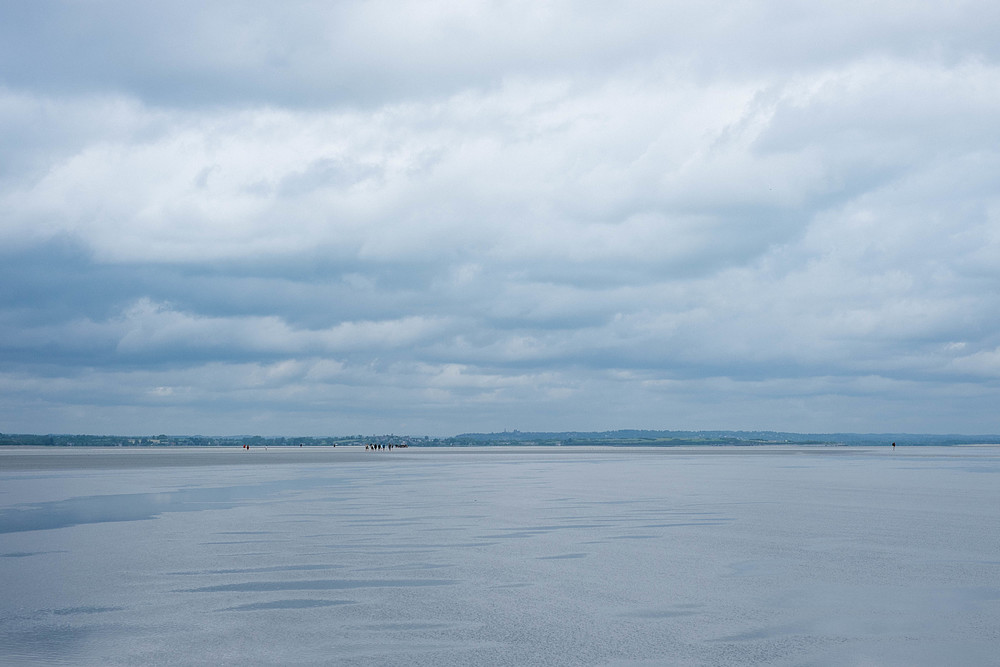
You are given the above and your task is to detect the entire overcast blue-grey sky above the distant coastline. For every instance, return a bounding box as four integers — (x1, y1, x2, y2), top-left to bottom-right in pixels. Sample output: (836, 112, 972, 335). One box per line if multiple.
(0, 0, 1000, 435)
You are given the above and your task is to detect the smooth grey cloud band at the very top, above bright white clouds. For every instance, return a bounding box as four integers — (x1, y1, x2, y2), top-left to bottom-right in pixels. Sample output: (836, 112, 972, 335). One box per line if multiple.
(0, 1, 1000, 106)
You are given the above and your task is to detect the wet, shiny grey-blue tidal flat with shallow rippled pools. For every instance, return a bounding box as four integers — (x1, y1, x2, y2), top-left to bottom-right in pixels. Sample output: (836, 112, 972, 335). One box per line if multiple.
(0, 447, 1000, 665)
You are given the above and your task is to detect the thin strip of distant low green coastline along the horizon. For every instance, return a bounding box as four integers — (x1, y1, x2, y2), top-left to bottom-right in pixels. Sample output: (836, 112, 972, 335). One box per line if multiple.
(0, 429, 1000, 447)
